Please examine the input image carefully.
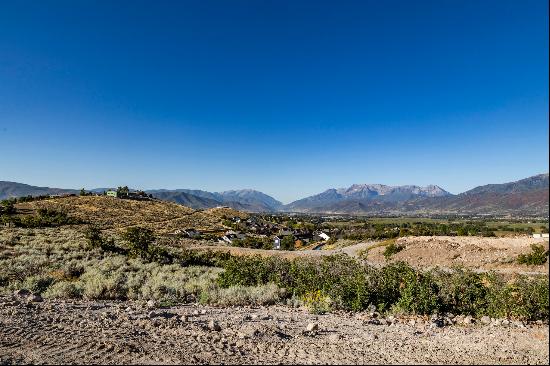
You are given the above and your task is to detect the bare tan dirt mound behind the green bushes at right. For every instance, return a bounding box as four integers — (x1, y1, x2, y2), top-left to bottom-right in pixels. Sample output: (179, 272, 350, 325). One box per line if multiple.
(367, 236, 548, 274)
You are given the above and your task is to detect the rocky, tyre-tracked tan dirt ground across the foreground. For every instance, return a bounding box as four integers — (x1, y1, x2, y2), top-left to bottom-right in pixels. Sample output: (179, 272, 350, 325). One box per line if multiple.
(0, 296, 549, 364)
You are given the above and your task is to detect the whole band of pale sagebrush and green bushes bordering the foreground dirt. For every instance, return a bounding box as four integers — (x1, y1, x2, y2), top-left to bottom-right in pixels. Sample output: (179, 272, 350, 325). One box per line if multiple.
(0, 227, 548, 320)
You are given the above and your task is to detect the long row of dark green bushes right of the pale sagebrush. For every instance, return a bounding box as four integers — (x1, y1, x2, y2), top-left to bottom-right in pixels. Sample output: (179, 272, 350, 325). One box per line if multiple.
(217, 255, 548, 319)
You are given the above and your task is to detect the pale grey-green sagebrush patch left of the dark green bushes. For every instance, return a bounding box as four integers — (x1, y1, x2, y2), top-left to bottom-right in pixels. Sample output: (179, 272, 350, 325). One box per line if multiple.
(0, 226, 284, 305)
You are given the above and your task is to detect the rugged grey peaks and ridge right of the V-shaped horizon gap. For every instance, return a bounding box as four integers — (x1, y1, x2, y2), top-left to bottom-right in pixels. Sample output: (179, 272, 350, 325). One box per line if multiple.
(282, 173, 549, 215)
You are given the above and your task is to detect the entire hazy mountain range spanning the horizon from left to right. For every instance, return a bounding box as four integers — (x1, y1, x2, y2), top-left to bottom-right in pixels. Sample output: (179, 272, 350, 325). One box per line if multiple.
(0, 173, 549, 215)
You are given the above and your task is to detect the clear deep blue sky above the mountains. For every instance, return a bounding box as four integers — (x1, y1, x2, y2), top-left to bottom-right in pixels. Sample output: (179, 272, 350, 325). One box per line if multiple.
(0, 0, 549, 203)
